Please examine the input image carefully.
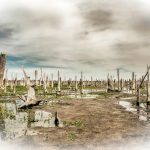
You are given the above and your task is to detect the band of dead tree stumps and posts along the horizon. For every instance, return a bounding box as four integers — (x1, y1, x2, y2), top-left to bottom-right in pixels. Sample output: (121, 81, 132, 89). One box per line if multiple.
(0, 54, 150, 107)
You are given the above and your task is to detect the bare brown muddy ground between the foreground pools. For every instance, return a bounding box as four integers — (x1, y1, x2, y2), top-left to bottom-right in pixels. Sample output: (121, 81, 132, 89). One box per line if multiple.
(9, 94, 148, 149)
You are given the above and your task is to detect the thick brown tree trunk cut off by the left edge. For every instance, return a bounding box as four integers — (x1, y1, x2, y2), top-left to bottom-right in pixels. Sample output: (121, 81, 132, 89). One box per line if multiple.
(0, 53, 6, 88)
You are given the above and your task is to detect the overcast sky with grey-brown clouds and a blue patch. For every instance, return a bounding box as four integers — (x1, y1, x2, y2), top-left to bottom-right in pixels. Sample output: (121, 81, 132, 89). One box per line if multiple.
(0, 0, 150, 77)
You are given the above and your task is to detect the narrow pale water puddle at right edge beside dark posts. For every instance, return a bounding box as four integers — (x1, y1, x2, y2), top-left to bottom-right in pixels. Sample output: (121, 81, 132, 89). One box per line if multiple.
(119, 101, 150, 122)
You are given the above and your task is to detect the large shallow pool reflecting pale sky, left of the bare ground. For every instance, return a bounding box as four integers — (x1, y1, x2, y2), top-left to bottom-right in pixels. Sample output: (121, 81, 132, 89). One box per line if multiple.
(0, 100, 63, 140)
